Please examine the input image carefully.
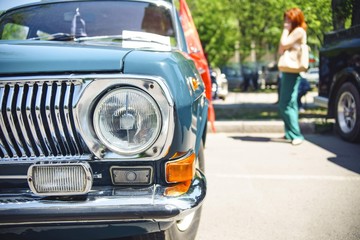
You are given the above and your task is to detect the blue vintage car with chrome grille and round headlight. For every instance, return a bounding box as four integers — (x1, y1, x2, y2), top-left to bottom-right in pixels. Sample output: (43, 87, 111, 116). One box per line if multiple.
(0, 0, 208, 240)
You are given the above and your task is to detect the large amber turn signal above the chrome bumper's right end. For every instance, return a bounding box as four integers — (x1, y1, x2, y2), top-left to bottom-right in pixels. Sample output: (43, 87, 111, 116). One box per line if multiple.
(166, 153, 196, 183)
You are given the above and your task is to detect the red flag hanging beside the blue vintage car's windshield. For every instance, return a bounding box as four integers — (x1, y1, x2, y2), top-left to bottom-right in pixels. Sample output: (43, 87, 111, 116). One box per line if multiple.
(180, 0, 215, 132)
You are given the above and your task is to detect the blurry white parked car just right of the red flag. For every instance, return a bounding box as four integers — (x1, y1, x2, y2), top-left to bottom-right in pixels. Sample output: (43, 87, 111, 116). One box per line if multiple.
(210, 68, 229, 100)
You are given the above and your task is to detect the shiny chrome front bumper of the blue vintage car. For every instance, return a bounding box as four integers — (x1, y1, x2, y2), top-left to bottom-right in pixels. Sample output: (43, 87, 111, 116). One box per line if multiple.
(0, 172, 206, 227)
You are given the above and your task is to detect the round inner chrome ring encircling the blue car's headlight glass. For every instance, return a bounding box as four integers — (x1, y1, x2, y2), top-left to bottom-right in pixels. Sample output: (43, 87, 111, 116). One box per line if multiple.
(93, 86, 163, 156)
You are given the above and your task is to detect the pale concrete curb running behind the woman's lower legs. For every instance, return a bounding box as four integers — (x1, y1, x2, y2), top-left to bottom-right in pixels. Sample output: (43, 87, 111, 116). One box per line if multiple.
(208, 120, 315, 134)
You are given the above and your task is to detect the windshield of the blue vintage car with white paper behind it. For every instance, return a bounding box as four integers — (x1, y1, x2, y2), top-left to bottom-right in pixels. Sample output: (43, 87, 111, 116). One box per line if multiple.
(0, 1, 177, 46)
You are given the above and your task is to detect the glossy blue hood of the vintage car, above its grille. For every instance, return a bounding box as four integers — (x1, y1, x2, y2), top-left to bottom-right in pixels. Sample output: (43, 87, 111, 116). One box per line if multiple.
(0, 41, 129, 75)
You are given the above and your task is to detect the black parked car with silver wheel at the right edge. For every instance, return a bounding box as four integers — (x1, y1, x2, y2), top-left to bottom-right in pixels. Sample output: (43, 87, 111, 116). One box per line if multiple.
(314, 25, 360, 142)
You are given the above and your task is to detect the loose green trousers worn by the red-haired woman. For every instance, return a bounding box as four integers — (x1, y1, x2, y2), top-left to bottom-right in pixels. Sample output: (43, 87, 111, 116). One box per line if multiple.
(279, 73, 304, 140)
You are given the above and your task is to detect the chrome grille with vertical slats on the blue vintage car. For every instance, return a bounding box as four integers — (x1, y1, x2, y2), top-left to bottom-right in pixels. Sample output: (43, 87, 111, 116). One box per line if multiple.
(0, 80, 84, 159)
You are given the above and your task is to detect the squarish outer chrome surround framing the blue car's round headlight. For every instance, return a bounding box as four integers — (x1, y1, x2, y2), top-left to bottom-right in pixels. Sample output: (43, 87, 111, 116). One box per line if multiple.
(76, 74, 176, 161)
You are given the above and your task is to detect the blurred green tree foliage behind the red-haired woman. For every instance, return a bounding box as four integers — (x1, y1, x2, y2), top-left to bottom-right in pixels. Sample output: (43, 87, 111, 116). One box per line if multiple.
(187, 0, 333, 66)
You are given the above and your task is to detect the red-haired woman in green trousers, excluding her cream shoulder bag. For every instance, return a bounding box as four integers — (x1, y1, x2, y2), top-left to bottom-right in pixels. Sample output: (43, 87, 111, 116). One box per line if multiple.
(279, 8, 307, 145)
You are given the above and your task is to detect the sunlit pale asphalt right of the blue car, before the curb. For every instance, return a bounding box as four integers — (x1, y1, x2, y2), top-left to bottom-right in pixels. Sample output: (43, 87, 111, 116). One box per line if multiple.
(197, 133, 360, 240)
